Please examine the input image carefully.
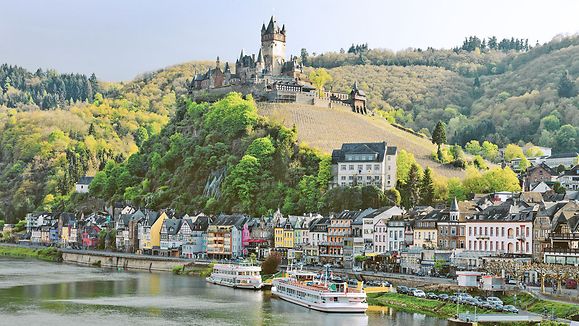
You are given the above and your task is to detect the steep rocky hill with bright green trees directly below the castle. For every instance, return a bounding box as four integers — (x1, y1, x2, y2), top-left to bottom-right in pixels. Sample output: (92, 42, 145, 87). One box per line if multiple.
(90, 93, 404, 215)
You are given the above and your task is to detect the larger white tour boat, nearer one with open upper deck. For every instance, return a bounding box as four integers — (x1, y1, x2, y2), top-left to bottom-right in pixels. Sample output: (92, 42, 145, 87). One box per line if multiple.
(271, 267, 368, 313)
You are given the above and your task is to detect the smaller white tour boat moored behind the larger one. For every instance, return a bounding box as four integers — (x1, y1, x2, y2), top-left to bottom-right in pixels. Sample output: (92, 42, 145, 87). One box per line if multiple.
(206, 264, 263, 289)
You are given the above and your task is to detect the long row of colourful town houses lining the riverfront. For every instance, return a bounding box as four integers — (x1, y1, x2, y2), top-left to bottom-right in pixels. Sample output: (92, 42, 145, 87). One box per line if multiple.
(20, 192, 579, 272)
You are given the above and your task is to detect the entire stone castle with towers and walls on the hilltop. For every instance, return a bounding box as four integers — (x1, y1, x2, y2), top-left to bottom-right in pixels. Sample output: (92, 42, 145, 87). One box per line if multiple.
(189, 16, 367, 114)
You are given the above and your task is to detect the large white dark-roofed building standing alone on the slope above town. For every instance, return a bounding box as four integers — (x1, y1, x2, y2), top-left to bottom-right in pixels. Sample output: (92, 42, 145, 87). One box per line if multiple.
(330, 142, 398, 190)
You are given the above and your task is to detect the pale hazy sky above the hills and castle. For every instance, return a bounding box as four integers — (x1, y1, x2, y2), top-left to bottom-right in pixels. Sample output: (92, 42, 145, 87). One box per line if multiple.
(0, 0, 579, 81)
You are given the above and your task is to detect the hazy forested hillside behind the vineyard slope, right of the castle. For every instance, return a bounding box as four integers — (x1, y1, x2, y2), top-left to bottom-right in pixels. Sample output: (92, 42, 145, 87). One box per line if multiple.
(318, 36, 579, 152)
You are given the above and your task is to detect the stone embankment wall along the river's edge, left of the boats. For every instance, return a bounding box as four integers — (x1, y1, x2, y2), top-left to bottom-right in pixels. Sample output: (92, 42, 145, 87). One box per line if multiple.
(62, 250, 208, 272)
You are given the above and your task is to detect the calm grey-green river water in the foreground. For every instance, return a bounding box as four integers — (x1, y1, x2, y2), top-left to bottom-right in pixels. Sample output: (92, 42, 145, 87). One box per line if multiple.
(0, 257, 447, 326)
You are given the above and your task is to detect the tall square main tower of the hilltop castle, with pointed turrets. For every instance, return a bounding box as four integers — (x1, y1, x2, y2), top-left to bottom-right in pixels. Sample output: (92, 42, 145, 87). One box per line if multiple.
(261, 16, 286, 75)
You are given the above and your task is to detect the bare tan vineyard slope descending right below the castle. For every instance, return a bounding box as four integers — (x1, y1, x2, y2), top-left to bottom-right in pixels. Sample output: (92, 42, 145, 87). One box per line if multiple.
(258, 103, 464, 177)
